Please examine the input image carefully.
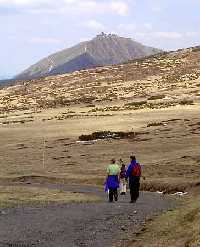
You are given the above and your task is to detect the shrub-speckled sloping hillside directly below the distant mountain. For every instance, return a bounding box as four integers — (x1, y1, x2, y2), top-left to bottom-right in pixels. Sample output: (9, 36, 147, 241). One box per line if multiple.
(0, 47, 200, 112)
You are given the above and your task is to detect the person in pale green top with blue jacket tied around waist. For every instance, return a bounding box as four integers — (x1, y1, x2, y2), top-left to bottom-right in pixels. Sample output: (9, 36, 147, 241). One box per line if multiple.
(106, 159, 120, 202)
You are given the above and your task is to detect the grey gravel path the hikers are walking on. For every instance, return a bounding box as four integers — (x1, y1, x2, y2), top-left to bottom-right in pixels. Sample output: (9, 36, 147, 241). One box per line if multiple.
(0, 185, 174, 247)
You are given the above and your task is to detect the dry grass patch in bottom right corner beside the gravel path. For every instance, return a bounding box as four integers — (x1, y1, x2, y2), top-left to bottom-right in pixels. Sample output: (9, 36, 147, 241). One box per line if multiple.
(129, 196, 200, 247)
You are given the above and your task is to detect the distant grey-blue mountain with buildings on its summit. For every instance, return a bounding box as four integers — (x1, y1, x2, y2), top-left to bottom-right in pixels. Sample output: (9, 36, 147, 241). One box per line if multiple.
(15, 33, 161, 80)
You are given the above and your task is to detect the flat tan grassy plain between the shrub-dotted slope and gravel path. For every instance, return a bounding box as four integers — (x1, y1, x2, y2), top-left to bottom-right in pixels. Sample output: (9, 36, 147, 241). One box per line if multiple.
(0, 105, 200, 189)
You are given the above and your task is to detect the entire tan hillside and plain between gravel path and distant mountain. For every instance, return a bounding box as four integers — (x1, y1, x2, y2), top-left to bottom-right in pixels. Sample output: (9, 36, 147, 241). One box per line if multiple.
(0, 45, 200, 246)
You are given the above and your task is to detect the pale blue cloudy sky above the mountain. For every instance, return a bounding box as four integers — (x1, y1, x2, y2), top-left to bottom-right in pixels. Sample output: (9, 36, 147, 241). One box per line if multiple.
(0, 0, 200, 78)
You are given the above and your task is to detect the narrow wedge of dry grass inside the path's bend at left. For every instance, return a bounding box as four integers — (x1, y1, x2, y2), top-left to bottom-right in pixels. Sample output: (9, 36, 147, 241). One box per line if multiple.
(0, 186, 100, 208)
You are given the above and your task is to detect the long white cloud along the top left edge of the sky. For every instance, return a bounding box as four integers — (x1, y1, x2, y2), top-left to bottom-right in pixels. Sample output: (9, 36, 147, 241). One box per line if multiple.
(0, 0, 129, 16)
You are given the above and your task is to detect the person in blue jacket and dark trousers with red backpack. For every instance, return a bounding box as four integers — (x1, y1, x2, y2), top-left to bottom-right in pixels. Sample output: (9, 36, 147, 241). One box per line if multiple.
(126, 156, 141, 203)
